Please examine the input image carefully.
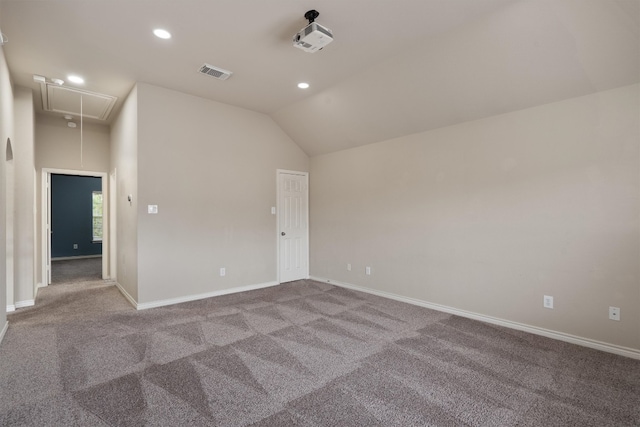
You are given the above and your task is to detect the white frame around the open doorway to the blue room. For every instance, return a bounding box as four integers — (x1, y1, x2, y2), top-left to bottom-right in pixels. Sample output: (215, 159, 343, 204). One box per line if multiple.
(40, 168, 110, 286)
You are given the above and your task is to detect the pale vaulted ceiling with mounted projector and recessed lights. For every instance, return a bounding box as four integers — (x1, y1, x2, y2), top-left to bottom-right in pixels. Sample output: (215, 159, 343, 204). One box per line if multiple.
(0, 0, 640, 156)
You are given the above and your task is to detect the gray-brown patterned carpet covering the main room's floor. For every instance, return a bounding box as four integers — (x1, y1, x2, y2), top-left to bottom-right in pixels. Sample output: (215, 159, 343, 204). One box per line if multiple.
(0, 280, 640, 426)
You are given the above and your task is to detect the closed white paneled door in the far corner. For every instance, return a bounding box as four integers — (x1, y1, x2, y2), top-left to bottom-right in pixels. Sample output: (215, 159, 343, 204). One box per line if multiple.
(278, 171, 309, 283)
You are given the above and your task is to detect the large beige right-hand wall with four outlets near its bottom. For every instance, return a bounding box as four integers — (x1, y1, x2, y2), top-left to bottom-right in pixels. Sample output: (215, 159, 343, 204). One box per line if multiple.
(310, 85, 640, 349)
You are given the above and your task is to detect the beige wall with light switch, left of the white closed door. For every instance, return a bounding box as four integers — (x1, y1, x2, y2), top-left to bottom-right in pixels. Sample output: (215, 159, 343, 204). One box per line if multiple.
(136, 84, 308, 303)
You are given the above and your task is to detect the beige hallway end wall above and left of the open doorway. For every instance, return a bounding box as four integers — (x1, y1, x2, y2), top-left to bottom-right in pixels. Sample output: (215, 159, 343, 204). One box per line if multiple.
(35, 115, 110, 284)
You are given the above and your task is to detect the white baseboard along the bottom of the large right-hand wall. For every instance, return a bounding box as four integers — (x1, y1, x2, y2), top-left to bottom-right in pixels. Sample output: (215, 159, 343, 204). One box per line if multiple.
(310, 276, 640, 360)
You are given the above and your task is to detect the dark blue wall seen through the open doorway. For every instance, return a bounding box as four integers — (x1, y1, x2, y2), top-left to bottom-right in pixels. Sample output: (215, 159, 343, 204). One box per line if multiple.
(51, 174, 102, 258)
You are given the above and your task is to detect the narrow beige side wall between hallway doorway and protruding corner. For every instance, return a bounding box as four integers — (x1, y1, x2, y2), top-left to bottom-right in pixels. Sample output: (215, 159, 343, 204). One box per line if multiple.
(109, 86, 138, 301)
